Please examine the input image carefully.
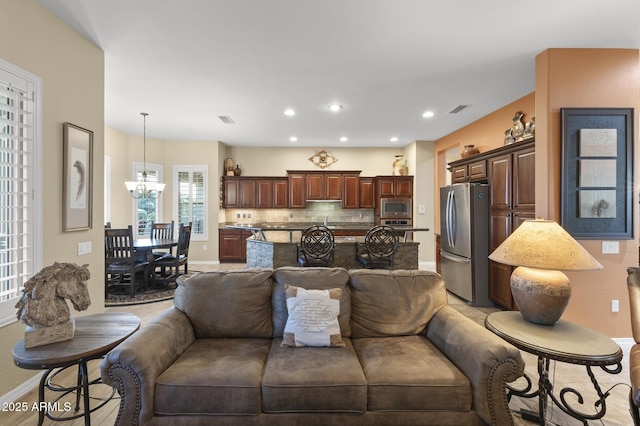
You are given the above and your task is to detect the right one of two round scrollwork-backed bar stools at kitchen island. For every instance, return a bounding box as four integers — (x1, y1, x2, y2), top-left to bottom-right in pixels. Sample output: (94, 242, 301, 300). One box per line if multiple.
(356, 225, 399, 269)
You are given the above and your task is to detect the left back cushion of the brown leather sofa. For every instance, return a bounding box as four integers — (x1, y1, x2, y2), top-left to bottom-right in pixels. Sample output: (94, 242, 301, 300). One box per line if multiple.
(174, 269, 273, 338)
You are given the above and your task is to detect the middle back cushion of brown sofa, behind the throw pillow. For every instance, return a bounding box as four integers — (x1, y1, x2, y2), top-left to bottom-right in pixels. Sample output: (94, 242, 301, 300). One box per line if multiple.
(271, 266, 351, 337)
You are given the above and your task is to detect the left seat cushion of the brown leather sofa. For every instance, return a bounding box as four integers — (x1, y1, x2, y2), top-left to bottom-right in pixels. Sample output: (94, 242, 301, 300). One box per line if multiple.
(154, 338, 271, 415)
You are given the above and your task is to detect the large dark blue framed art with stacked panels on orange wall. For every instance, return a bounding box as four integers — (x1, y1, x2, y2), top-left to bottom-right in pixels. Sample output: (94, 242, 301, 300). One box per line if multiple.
(561, 108, 633, 240)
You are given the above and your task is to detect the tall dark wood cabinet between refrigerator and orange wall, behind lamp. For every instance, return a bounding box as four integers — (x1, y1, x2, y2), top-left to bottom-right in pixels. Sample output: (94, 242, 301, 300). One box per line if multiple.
(487, 142, 535, 309)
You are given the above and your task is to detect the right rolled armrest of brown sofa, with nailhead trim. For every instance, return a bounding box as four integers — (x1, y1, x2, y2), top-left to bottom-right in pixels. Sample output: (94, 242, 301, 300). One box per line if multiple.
(426, 306, 524, 425)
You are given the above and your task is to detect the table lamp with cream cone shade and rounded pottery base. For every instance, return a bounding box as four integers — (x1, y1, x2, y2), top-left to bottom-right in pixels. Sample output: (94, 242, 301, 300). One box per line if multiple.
(489, 219, 602, 325)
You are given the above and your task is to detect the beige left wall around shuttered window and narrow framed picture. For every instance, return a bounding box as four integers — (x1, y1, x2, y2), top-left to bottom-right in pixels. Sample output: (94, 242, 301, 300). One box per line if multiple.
(0, 0, 104, 395)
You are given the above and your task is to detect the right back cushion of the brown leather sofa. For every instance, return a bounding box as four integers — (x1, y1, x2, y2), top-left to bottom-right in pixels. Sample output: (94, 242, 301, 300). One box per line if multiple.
(350, 269, 447, 338)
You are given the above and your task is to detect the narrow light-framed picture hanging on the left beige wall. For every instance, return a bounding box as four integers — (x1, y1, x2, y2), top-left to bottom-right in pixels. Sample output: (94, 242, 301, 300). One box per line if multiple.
(62, 123, 93, 231)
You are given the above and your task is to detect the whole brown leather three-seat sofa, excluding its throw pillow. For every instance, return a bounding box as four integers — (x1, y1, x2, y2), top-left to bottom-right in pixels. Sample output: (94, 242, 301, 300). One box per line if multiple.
(101, 267, 524, 426)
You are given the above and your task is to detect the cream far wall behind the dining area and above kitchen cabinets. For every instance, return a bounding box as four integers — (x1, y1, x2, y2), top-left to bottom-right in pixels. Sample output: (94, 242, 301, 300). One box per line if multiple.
(104, 141, 435, 262)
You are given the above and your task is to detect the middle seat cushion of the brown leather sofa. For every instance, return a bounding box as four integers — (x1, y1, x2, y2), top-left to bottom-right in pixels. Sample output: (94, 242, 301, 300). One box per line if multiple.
(262, 338, 367, 413)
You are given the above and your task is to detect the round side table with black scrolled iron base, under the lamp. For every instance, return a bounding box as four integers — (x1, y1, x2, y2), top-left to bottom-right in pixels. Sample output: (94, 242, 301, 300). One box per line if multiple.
(485, 312, 622, 425)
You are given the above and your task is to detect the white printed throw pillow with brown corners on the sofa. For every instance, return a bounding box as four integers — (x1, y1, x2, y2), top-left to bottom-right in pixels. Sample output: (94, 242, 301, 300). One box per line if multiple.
(282, 284, 346, 348)
